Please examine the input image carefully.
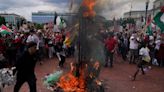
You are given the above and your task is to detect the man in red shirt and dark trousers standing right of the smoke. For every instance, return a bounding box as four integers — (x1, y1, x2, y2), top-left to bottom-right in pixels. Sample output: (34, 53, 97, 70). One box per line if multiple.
(105, 35, 117, 67)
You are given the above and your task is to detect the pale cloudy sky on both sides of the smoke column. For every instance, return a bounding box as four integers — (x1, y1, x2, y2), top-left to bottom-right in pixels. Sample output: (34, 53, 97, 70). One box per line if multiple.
(0, 0, 154, 21)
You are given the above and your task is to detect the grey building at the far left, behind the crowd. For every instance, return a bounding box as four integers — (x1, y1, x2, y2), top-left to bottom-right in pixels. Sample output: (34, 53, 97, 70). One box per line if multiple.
(0, 13, 25, 29)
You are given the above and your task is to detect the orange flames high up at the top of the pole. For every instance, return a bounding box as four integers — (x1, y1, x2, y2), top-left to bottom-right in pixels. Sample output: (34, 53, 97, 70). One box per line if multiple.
(82, 0, 96, 17)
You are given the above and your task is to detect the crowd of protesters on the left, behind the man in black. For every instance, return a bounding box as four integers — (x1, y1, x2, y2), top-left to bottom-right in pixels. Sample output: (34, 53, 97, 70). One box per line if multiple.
(0, 23, 73, 68)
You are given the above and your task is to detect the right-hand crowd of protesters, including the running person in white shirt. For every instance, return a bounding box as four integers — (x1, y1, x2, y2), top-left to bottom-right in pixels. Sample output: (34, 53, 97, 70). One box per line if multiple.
(102, 29, 164, 80)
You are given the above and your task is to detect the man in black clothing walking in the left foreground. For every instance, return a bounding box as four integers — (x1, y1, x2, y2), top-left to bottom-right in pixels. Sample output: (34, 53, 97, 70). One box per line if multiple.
(14, 42, 37, 92)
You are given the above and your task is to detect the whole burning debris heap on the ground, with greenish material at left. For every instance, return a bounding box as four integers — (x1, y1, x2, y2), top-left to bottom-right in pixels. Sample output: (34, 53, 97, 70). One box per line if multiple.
(44, 61, 104, 92)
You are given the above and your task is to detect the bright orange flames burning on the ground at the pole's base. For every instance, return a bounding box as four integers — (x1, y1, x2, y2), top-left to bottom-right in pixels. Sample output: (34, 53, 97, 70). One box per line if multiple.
(58, 63, 86, 92)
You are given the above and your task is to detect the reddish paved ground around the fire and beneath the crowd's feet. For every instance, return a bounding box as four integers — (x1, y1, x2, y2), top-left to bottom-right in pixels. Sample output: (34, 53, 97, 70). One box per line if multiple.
(3, 57, 164, 92)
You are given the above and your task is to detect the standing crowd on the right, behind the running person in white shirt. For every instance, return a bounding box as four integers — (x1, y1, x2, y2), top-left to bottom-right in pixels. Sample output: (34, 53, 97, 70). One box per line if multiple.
(104, 29, 164, 66)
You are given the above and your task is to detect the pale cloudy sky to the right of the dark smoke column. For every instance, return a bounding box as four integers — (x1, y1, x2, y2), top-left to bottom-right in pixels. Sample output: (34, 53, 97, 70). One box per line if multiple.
(96, 0, 155, 19)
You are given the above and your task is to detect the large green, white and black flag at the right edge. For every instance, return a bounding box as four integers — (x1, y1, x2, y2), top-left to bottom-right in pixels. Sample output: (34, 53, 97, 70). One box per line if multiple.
(154, 6, 164, 33)
